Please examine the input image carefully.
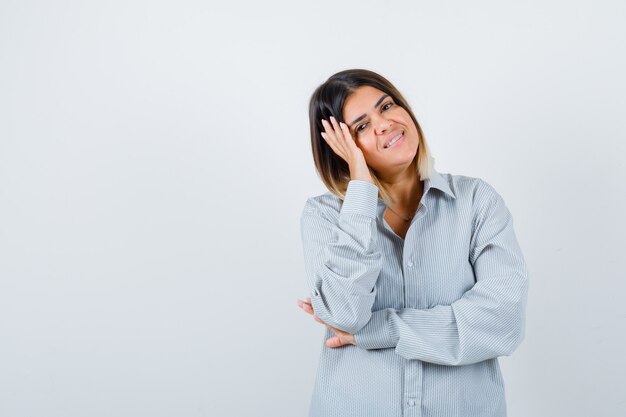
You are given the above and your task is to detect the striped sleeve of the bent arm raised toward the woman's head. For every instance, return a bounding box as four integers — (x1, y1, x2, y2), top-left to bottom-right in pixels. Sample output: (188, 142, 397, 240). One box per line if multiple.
(301, 180, 382, 333)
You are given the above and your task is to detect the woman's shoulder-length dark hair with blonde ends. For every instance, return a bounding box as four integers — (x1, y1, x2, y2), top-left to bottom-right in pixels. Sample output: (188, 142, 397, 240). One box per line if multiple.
(309, 69, 434, 203)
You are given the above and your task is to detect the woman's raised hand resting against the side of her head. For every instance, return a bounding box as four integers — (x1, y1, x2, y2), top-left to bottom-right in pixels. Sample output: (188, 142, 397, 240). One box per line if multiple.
(322, 116, 374, 184)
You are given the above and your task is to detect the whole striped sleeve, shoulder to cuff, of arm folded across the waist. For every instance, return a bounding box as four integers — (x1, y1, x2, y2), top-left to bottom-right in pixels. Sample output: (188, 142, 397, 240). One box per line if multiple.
(355, 186, 528, 365)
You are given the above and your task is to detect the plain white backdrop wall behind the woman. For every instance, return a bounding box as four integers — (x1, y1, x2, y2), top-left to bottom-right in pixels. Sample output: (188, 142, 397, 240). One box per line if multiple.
(0, 0, 626, 417)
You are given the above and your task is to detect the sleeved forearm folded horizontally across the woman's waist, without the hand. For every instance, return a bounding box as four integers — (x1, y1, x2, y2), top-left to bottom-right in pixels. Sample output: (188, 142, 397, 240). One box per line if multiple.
(354, 276, 527, 365)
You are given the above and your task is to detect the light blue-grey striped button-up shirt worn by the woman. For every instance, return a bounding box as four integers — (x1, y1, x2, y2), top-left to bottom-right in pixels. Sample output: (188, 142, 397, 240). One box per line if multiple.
(301, 171, 528, 417)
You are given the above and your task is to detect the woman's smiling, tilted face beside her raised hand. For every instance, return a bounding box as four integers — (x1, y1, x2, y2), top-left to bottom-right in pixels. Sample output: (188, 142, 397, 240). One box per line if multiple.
(343, 86, 419, 176)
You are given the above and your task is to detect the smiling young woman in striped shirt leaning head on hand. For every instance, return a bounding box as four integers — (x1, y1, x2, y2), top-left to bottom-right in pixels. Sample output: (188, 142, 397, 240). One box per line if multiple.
(298, 70, 528, 417)
